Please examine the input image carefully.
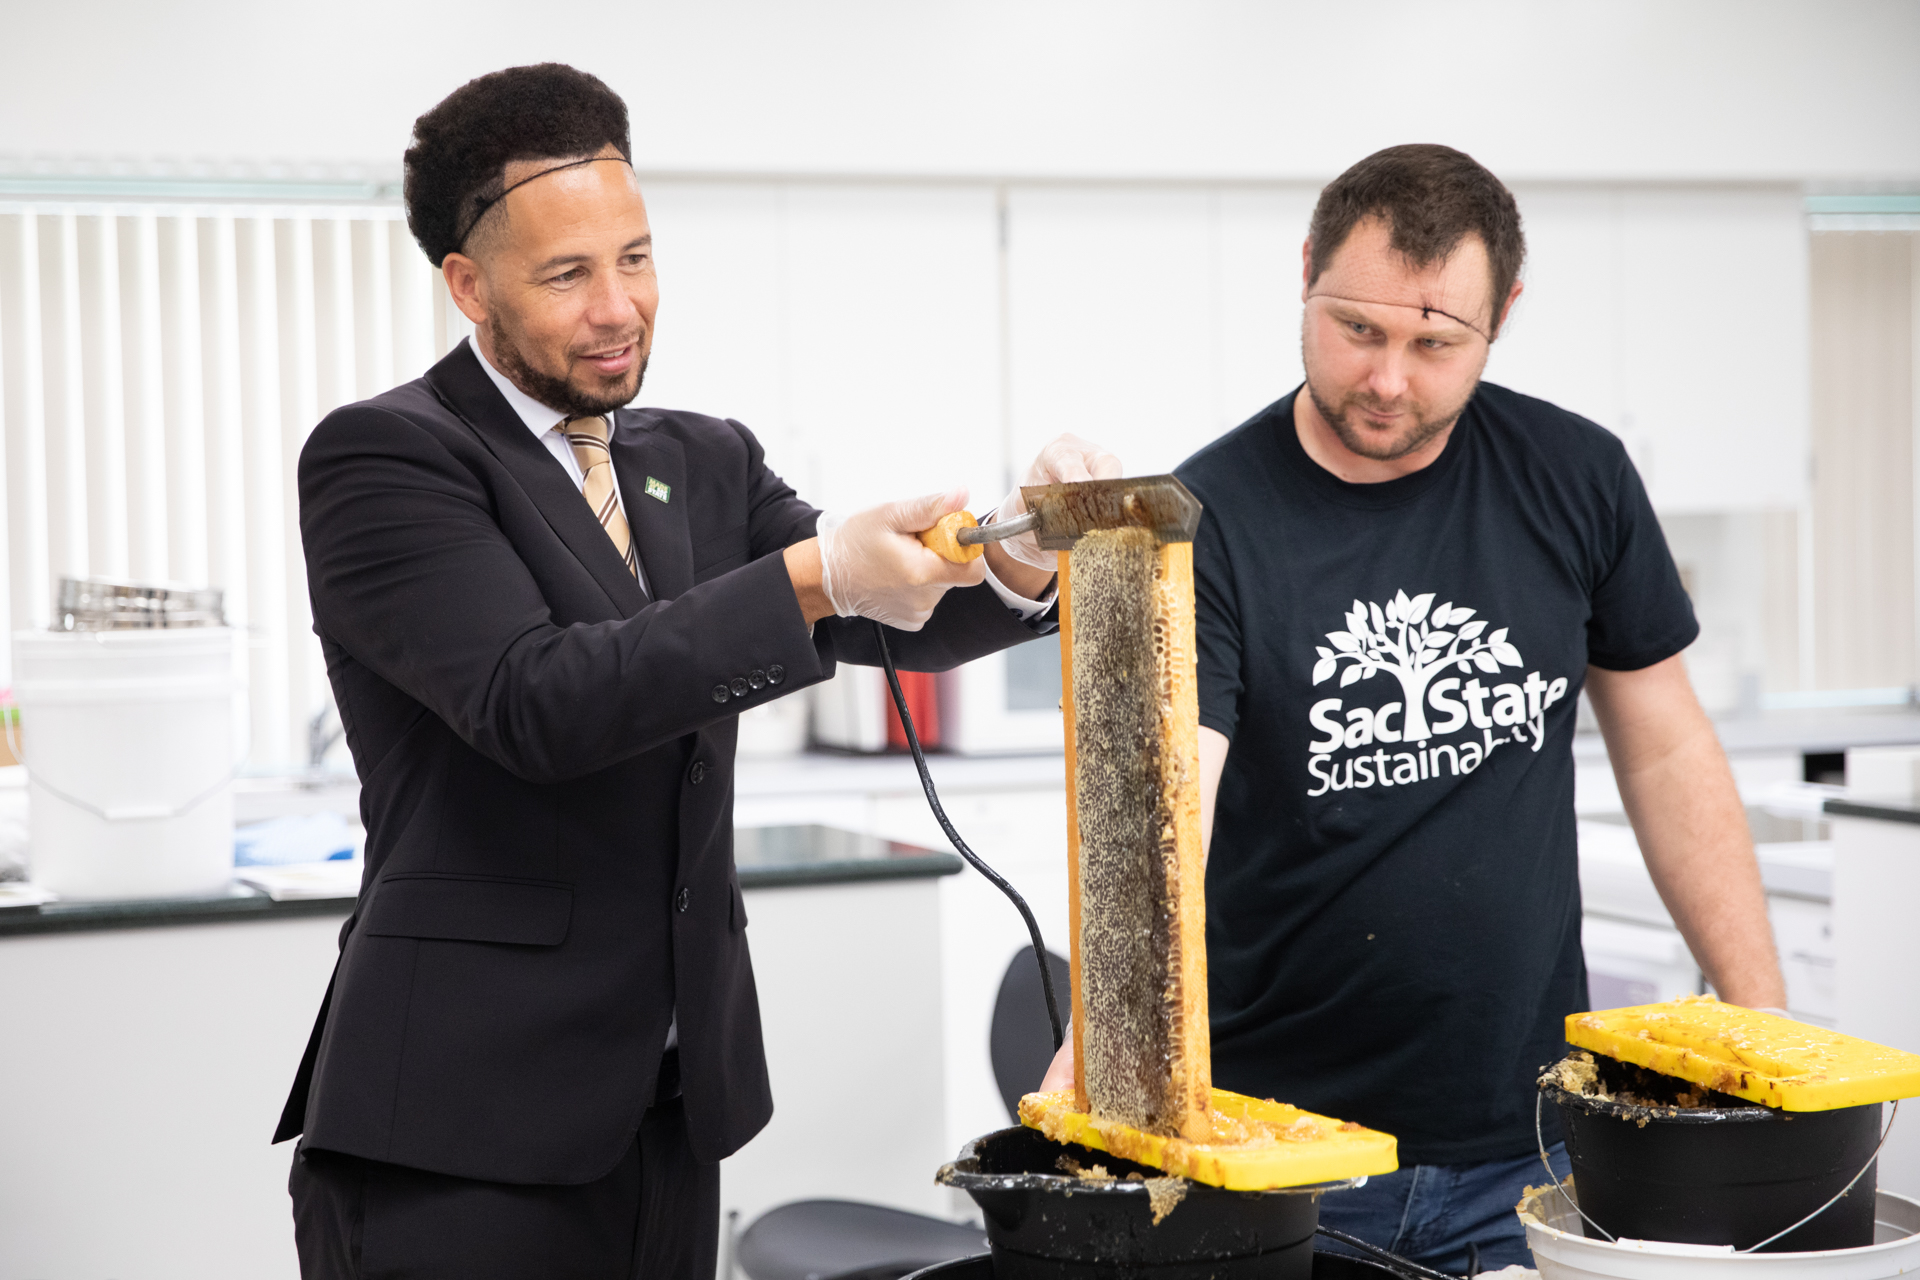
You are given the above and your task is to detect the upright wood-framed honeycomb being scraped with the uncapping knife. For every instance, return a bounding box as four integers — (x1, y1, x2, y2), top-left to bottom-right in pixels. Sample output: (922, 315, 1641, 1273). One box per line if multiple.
(1064, 528, 1212, 1140)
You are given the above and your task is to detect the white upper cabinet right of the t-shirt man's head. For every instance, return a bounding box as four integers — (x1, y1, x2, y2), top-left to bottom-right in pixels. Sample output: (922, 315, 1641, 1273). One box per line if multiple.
(1486, 184, 1809, 514)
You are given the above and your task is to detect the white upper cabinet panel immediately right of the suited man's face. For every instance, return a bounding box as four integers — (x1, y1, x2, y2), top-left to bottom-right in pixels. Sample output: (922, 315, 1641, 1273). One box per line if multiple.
(637, 182, 1006, 510)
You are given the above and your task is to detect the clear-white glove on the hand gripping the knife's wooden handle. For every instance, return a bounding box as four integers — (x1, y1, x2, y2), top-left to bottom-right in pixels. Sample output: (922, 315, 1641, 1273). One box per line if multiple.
(814, 489, 987, 631)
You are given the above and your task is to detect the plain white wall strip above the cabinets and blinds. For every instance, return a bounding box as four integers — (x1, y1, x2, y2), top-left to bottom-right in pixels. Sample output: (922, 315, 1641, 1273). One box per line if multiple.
(0, 0, 1920, 180)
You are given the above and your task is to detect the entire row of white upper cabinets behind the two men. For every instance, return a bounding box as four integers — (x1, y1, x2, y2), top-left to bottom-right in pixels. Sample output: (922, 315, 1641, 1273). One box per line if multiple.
(641, 180, 1807, 512)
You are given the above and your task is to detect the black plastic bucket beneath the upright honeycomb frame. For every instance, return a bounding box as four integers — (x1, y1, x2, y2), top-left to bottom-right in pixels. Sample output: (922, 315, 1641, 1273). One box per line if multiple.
(939, 1128, 1350, 1280)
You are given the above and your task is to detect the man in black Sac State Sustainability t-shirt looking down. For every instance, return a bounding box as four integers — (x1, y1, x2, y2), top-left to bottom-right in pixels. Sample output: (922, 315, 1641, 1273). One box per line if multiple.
(1050, 146, 1784, 1272)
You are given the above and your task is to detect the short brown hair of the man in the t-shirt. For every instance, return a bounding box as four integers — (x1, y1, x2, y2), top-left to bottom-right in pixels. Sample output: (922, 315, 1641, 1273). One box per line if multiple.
(1308, 142, 1526, 334)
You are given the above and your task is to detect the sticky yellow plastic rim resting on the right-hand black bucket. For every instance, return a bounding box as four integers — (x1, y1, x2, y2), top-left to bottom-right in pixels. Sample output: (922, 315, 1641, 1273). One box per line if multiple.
(1567, 996, 1920, 1111)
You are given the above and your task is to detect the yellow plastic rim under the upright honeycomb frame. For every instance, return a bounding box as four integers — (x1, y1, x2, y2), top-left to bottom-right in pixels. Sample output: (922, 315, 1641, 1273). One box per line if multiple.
(1020, 1088, 1400, 1192)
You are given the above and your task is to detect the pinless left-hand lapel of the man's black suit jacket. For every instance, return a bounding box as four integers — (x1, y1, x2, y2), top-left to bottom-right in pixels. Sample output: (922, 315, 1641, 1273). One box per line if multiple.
(426, 342, 653, 618)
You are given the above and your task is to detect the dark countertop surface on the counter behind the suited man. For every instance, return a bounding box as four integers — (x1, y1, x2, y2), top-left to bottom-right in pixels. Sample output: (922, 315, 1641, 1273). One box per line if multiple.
(0, 827, 964, 936)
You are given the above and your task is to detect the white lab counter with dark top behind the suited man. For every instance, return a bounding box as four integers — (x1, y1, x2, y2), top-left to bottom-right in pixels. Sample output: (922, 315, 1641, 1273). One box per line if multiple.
(0, 825, 962, 1280)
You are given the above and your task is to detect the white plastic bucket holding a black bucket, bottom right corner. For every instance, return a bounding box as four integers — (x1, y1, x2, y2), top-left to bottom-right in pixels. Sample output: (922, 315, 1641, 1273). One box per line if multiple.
(1519, 1171, 1920, 1280)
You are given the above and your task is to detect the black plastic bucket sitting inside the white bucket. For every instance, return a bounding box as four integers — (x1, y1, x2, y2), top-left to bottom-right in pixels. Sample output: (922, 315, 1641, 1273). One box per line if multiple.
(1540, 1055, 1880, 1253)
